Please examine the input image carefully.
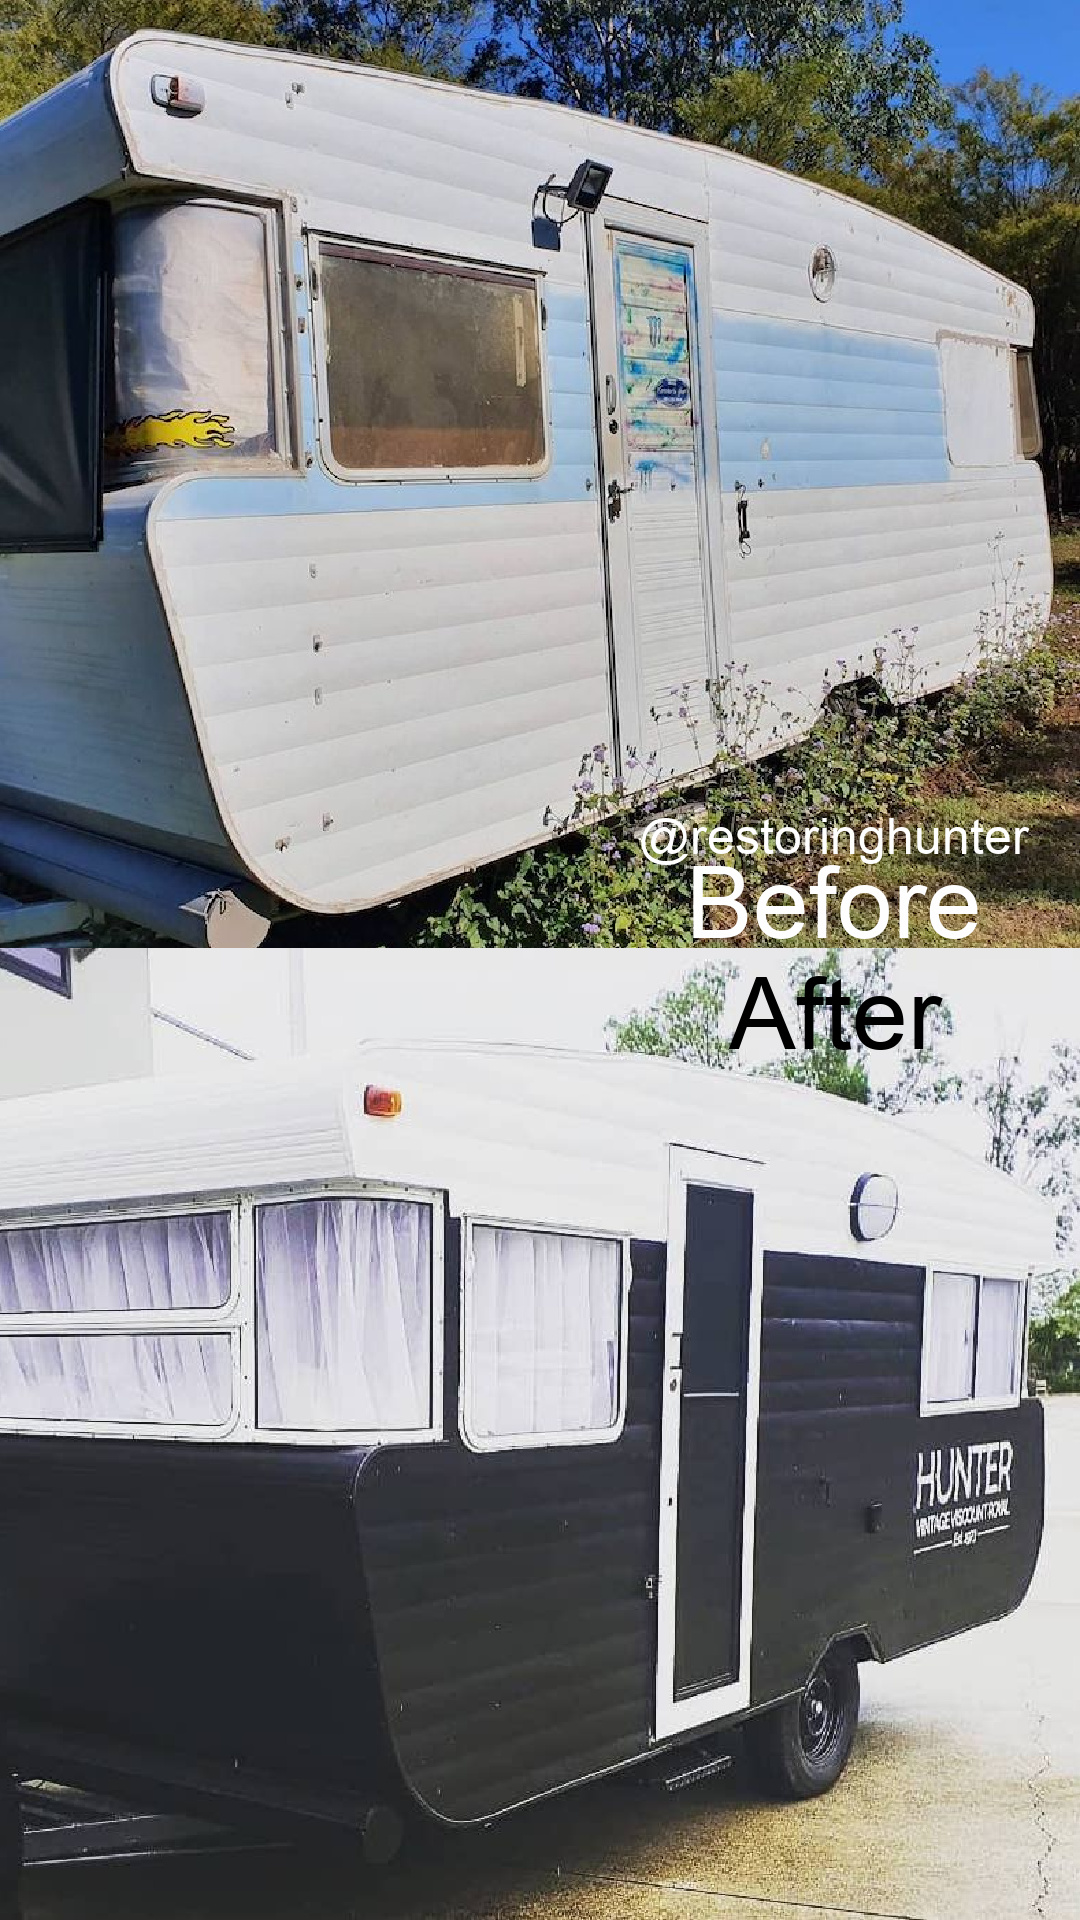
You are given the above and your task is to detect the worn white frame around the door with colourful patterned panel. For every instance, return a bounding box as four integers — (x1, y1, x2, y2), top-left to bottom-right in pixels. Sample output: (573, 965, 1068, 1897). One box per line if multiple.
(586, 196, 730, 766)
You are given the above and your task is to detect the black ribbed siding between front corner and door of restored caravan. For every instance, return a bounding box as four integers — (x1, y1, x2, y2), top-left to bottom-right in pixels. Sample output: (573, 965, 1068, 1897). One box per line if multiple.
(357, 1242, 665, 1820)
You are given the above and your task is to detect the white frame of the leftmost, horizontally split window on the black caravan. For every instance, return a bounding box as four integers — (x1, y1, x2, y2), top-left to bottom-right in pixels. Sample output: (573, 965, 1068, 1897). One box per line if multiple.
(0, 1192, 248, 1440)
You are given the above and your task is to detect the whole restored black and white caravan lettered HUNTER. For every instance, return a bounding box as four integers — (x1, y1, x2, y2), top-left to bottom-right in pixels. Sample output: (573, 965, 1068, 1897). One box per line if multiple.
(0, 1044, 1055, 1845)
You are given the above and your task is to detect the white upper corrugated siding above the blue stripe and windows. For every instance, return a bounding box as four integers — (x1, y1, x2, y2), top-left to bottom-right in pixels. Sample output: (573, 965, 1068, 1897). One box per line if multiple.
(110, 35, 1032, 342)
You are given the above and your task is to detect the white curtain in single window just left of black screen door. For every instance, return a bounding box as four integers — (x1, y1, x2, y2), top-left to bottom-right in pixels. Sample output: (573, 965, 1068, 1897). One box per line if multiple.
(467, 1227, 623, 1438)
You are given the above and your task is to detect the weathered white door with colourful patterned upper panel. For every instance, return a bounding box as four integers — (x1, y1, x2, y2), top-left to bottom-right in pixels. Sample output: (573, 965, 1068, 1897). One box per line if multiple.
(590, 200, 719, 774)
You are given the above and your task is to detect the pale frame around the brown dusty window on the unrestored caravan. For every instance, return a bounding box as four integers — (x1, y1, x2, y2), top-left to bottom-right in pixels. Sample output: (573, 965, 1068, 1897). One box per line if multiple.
(307, 230, 553, 486)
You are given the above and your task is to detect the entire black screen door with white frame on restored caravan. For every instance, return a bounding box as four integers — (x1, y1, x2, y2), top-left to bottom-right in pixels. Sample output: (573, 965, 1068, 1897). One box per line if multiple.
(655, 1146, 761, 1740)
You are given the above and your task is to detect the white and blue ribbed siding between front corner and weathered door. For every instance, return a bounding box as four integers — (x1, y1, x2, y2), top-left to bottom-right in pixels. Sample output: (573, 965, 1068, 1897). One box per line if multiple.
(154, 278, 611, 906)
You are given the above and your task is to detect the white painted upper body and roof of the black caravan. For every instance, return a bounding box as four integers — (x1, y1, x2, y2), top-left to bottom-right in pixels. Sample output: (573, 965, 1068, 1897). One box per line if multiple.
(0, 1043, 1055, 1271)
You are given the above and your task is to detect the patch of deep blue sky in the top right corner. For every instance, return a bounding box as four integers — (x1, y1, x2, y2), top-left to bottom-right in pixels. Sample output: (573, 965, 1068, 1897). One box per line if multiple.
(903, 0, 1080, 94)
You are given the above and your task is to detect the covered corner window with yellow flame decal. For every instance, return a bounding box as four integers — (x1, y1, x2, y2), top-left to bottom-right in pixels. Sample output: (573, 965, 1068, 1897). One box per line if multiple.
(106, 202, 279, 488)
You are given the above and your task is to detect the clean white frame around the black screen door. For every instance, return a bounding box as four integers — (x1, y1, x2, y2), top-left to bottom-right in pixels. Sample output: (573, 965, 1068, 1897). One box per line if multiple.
(655, 1146, 765, 1740)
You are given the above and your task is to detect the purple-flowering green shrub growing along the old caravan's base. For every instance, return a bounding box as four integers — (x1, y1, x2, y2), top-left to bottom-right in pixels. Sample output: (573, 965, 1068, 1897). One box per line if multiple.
(411, 599, 1076, 947)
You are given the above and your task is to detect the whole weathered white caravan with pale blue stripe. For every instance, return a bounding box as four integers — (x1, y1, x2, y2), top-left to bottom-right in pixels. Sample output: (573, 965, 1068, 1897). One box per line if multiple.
(0, 33, 1051, 929)
